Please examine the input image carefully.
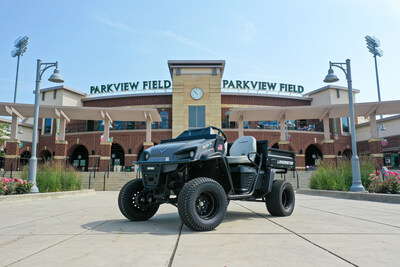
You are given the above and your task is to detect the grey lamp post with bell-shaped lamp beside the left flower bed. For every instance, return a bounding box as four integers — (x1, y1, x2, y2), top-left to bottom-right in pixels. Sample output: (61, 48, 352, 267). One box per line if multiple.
(28, 59, 64, 193)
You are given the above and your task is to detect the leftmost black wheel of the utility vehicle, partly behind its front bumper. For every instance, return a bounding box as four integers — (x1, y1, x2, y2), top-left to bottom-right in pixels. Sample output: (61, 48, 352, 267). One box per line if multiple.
(118, 179, 159, 221)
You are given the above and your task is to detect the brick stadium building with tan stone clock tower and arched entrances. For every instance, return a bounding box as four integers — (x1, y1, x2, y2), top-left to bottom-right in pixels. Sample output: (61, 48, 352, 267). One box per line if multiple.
(0, 60, 400, 174)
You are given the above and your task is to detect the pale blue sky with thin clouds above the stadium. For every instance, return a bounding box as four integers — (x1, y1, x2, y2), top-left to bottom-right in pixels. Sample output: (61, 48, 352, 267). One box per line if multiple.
(0, 0, 400, 103)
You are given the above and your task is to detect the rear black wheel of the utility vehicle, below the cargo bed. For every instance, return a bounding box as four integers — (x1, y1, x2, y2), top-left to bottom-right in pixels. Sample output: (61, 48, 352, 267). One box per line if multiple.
(265, 180, 295, 216)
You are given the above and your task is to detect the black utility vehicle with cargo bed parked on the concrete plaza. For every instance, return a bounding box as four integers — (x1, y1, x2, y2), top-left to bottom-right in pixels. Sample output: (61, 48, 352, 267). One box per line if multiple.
(118, 127, 295, 231)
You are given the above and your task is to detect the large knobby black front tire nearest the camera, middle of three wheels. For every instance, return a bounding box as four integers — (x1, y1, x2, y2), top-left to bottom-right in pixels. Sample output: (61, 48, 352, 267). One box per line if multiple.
(178, 178, 228, 231)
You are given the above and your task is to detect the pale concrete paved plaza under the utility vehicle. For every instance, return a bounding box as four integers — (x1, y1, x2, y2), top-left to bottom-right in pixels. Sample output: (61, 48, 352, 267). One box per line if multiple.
(0, 192, 400, 266)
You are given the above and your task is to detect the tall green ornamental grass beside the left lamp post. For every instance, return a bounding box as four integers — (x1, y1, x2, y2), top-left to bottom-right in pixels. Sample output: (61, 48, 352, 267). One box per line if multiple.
(21, 162, 82, 193)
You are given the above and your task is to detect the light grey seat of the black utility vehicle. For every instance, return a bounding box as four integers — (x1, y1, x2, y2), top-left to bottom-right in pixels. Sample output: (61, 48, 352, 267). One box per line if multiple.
(226, 136, 257, 164)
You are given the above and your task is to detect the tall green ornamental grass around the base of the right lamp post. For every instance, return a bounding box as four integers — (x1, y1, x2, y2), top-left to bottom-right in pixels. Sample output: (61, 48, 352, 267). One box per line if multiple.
(309, 158, 375, 191)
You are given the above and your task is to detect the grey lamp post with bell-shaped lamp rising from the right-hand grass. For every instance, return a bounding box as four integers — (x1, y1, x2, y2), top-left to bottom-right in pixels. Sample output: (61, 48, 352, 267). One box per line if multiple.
(324, 59, 365, 192)
